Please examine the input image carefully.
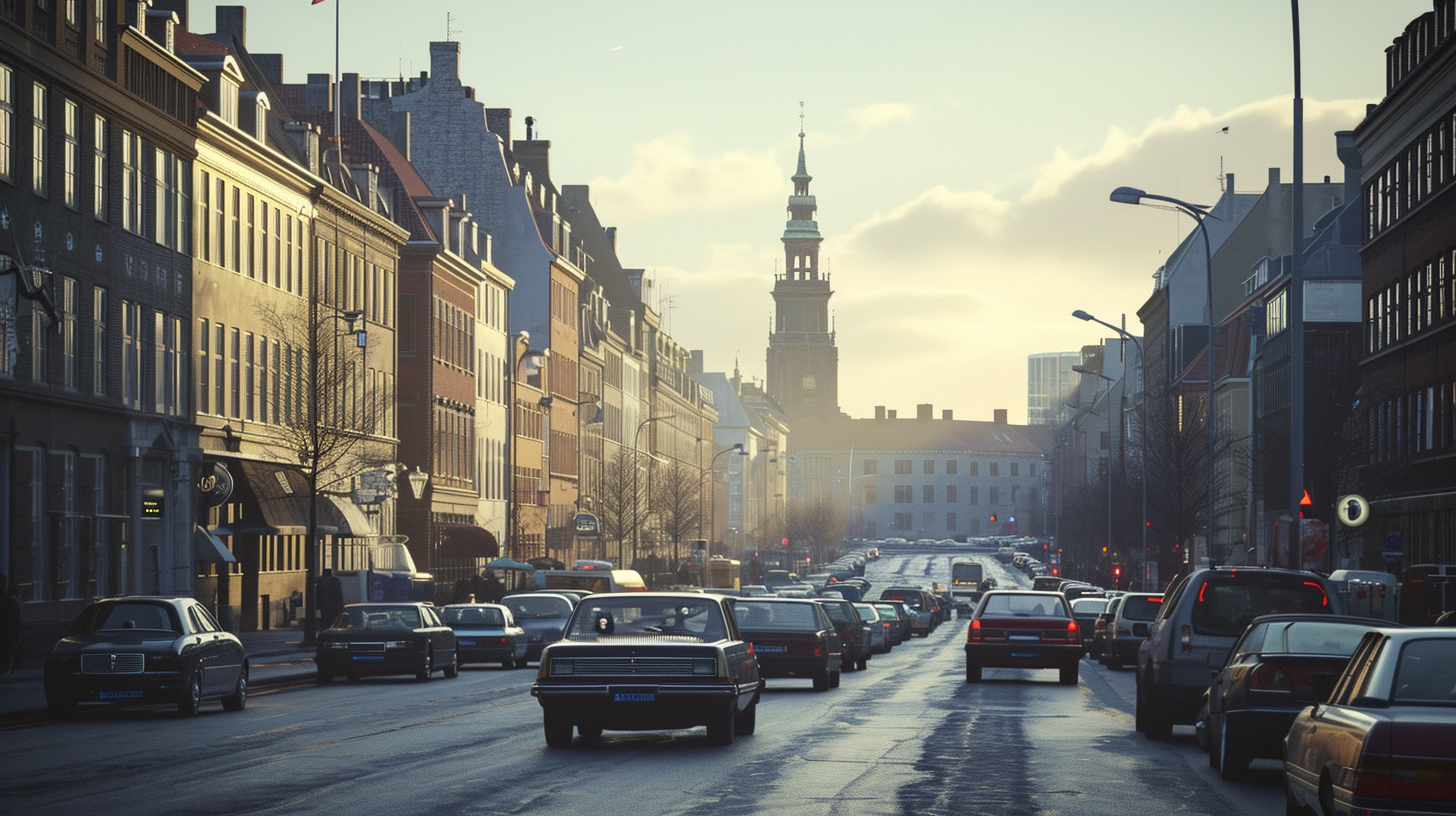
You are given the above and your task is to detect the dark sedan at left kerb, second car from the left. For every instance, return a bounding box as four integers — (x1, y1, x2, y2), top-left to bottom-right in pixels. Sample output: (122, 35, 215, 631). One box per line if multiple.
(313, 602, 460, 685)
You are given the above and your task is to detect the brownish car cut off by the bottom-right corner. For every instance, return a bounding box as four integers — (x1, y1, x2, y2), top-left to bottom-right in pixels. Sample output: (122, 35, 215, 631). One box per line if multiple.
(1284, 627, 1456, 816)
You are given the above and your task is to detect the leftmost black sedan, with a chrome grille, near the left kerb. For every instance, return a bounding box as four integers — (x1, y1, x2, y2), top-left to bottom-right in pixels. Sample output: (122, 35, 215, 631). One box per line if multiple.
(44, 595, 248, 718)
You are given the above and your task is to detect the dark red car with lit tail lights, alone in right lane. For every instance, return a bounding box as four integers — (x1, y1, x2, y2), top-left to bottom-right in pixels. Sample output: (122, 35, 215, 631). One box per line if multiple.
(965, 590, 1082, 685)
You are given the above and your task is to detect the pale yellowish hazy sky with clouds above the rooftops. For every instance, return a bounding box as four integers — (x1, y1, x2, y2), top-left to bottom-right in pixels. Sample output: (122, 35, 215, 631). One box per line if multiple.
(191, 0, 1433, 423)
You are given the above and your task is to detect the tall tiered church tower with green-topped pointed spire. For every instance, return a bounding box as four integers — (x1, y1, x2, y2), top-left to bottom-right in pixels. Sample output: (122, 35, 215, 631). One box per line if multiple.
(767, 112, 839, 427)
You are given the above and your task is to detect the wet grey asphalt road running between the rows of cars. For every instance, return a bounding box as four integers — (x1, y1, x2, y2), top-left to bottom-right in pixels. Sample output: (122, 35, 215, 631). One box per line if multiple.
(0, 551, 1283, 816)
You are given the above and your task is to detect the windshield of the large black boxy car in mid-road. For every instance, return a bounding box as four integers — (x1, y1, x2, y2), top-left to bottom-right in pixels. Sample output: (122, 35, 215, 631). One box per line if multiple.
(565, 595, 728, 643)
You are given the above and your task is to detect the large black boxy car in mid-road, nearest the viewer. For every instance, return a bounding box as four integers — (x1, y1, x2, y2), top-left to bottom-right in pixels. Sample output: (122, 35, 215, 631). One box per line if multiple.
(531, 592, 762, 748)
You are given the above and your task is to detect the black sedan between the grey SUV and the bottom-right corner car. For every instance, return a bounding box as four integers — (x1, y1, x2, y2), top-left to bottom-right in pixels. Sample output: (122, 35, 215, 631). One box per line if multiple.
(1204, 615, 1388, 780)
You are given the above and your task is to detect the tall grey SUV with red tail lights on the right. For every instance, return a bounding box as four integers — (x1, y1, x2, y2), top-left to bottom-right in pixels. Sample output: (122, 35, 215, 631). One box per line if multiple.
(1123, 567, 1340, 740)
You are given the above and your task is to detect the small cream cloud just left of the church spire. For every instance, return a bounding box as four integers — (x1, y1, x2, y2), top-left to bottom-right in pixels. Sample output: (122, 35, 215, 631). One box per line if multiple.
(591, 131, 783, 216)
